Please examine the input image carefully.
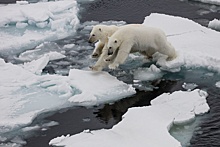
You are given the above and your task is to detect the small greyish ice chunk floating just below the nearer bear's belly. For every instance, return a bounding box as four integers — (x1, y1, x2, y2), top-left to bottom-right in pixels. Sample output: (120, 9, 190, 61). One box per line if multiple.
(134, 64, 163, 81)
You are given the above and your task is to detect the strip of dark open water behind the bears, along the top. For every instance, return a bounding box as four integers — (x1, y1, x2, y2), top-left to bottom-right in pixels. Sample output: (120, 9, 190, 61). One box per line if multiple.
(81, 0, 220, 25)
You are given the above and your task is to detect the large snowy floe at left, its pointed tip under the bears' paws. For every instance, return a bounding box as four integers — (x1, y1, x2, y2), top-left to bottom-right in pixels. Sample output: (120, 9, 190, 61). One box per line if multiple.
(0, 54, 135, 137)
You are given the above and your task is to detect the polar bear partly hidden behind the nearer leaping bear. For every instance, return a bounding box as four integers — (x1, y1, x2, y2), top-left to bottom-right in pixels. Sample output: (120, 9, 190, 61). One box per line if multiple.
(89, 24, 143, 71)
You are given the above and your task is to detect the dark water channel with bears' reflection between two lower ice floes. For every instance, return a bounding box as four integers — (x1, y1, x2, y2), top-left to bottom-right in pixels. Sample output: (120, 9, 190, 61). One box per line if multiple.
(25, 80, 182, 147)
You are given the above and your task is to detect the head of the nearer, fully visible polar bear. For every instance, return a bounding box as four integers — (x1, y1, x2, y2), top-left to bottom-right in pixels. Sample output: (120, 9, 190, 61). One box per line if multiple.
(107, 37, 122, 55)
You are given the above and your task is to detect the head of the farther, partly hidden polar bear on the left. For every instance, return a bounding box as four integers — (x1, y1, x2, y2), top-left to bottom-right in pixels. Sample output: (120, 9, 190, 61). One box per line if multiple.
(89, 25, 104, 43)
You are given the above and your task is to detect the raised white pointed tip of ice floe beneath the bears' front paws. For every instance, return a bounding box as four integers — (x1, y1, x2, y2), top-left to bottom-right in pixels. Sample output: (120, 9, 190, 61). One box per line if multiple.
(69, 69, 136, 106)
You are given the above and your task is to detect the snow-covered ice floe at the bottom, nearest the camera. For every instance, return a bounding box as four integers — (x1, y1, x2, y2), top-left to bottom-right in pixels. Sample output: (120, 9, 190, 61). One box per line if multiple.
(49, 89, 209, 147)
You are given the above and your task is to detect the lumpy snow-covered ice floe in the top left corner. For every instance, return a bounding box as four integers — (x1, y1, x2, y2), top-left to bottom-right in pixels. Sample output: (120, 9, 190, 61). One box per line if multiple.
(0, 0, 79, 55)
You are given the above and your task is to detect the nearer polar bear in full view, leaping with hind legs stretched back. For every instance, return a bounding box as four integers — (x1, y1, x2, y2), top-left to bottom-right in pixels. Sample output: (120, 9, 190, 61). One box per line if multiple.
(105, 26, 177, 69)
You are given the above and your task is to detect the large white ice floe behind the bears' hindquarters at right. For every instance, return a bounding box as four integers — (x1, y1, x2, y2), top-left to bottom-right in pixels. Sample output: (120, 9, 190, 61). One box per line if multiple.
(143, 13, 220, 72)
